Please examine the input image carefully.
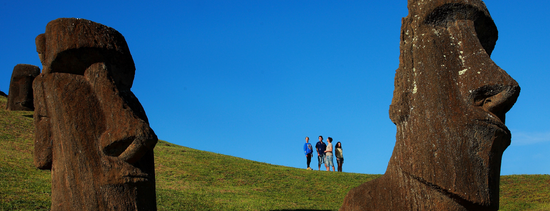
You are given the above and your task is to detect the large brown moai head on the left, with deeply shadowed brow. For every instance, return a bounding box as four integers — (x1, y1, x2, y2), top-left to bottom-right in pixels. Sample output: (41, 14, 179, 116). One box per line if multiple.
(33, 18, 158, 210)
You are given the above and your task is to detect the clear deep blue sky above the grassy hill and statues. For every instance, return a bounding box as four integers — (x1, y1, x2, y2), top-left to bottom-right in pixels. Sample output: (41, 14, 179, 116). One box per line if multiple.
(0, 0, 550, 175)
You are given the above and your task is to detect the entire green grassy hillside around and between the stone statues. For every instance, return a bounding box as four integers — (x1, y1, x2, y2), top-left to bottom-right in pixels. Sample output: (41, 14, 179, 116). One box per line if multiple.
(0, 97, 550, 210)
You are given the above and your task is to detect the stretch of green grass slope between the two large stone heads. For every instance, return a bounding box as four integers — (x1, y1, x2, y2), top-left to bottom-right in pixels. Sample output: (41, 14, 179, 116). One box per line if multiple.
(155, 142, 378, 210)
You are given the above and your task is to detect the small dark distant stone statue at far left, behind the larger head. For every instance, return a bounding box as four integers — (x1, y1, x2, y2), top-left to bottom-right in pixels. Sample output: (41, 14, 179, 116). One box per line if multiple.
(6, 64, 40, 111)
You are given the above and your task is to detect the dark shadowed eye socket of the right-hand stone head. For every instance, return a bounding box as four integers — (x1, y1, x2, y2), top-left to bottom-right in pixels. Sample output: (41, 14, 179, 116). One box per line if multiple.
(424, 3, 498, 56)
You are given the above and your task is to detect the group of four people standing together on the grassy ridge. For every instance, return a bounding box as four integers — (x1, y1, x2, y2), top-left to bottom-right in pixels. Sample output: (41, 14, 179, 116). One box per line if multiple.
(304, 136, 344, 172)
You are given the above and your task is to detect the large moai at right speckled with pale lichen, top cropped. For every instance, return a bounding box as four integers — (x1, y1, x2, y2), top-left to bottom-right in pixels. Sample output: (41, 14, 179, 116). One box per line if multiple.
(341, 0, 520, 210)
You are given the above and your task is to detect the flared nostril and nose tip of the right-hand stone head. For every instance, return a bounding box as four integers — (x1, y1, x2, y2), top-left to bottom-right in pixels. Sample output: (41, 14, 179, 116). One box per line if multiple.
(472, 84, 520, 123)
